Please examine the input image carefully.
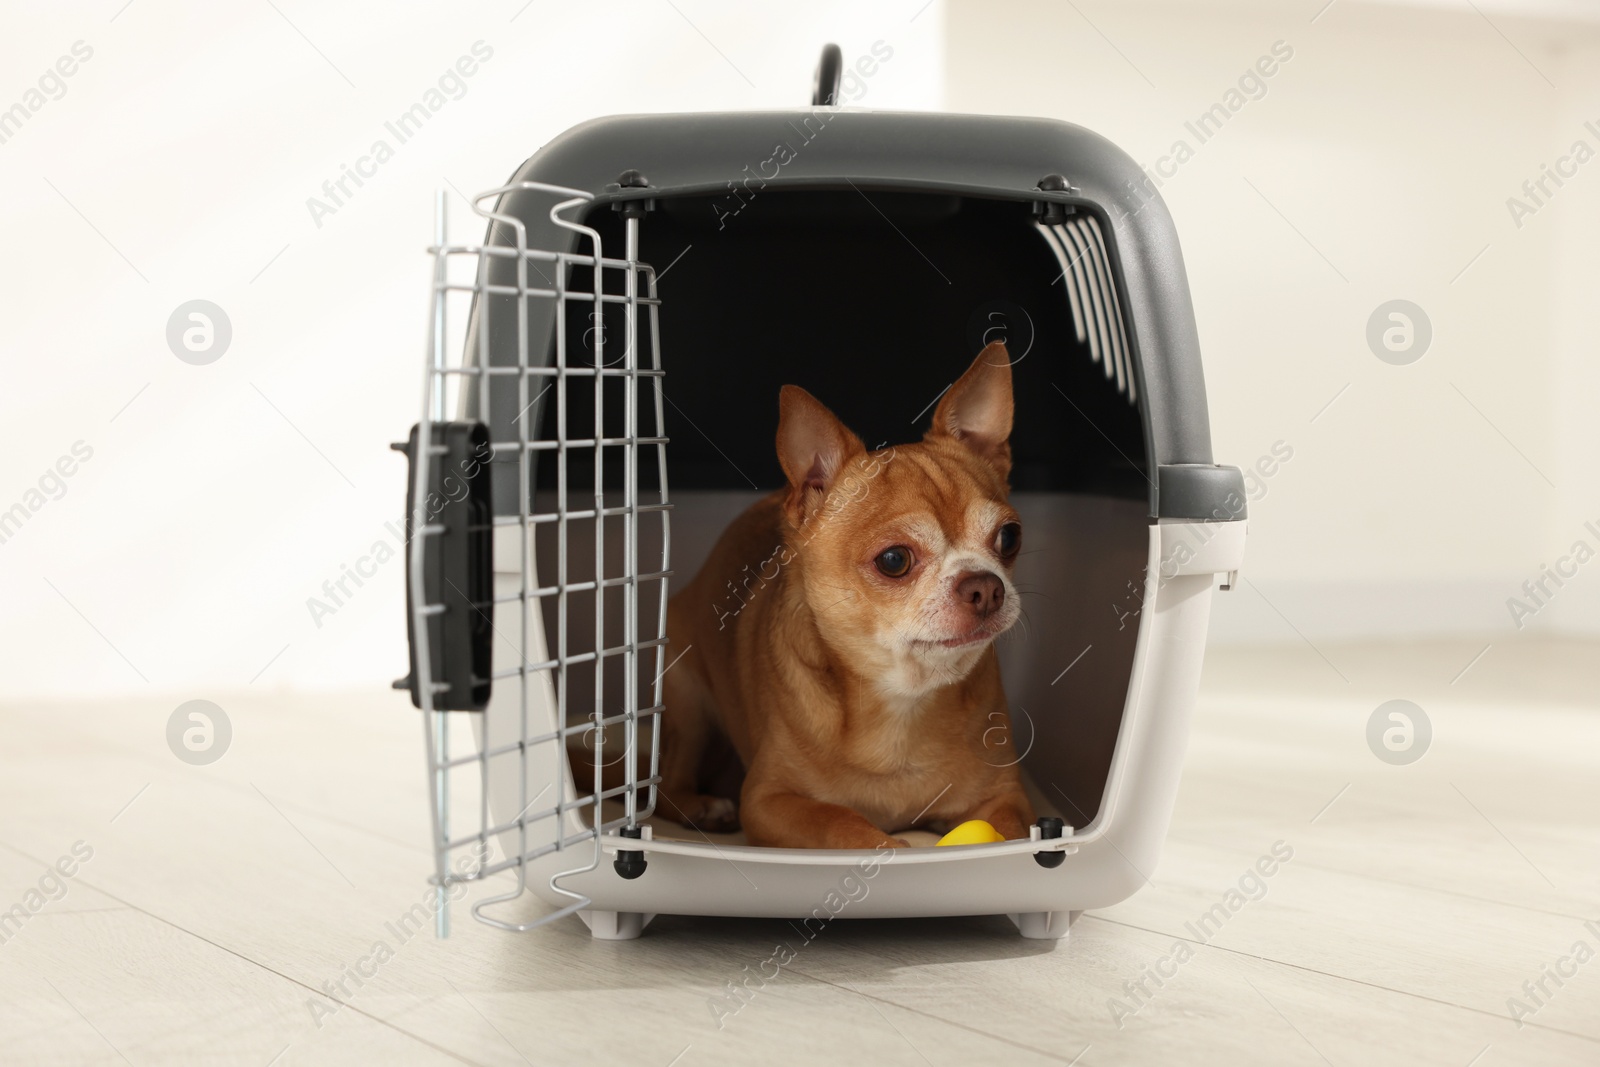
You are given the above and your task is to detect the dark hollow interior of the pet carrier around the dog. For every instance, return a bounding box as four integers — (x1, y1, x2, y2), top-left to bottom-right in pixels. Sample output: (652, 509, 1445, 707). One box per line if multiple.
(518, 187, 1150, 840)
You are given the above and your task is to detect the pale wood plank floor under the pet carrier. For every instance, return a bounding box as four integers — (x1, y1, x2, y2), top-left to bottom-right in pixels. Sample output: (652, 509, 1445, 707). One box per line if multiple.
(0, 641, 1600, 1067)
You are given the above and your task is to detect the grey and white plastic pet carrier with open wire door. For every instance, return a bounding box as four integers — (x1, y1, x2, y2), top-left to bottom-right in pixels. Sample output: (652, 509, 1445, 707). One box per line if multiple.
(397, 46, 1245, 937)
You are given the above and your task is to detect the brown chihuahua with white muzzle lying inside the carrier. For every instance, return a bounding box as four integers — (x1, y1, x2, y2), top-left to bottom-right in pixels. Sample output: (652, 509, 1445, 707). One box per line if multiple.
(661, 342, 1034, 848)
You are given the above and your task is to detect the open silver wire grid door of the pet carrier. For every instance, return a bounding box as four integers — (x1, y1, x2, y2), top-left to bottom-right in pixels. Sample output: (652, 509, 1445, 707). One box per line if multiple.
(408, 182, 670, 936)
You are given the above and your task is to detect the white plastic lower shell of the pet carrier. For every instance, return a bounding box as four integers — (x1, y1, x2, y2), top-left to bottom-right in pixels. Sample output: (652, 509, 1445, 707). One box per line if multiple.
(474, 520, 1246, 939)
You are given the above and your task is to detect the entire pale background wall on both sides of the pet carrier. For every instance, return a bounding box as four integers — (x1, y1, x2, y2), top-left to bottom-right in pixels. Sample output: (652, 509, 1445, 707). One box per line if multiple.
(0, 0, 1600, 697)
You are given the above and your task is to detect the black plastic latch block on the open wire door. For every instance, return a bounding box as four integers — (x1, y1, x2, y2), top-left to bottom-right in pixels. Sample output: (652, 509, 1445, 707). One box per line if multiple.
(392, 422, 494, 712)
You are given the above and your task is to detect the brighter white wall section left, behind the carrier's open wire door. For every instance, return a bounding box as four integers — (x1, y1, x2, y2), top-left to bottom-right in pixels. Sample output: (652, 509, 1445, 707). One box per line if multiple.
(0, 0, 942, 699)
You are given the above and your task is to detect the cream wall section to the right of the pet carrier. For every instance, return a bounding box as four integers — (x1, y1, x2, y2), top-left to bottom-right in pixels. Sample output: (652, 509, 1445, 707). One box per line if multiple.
(947, 0, 1600, 641)
